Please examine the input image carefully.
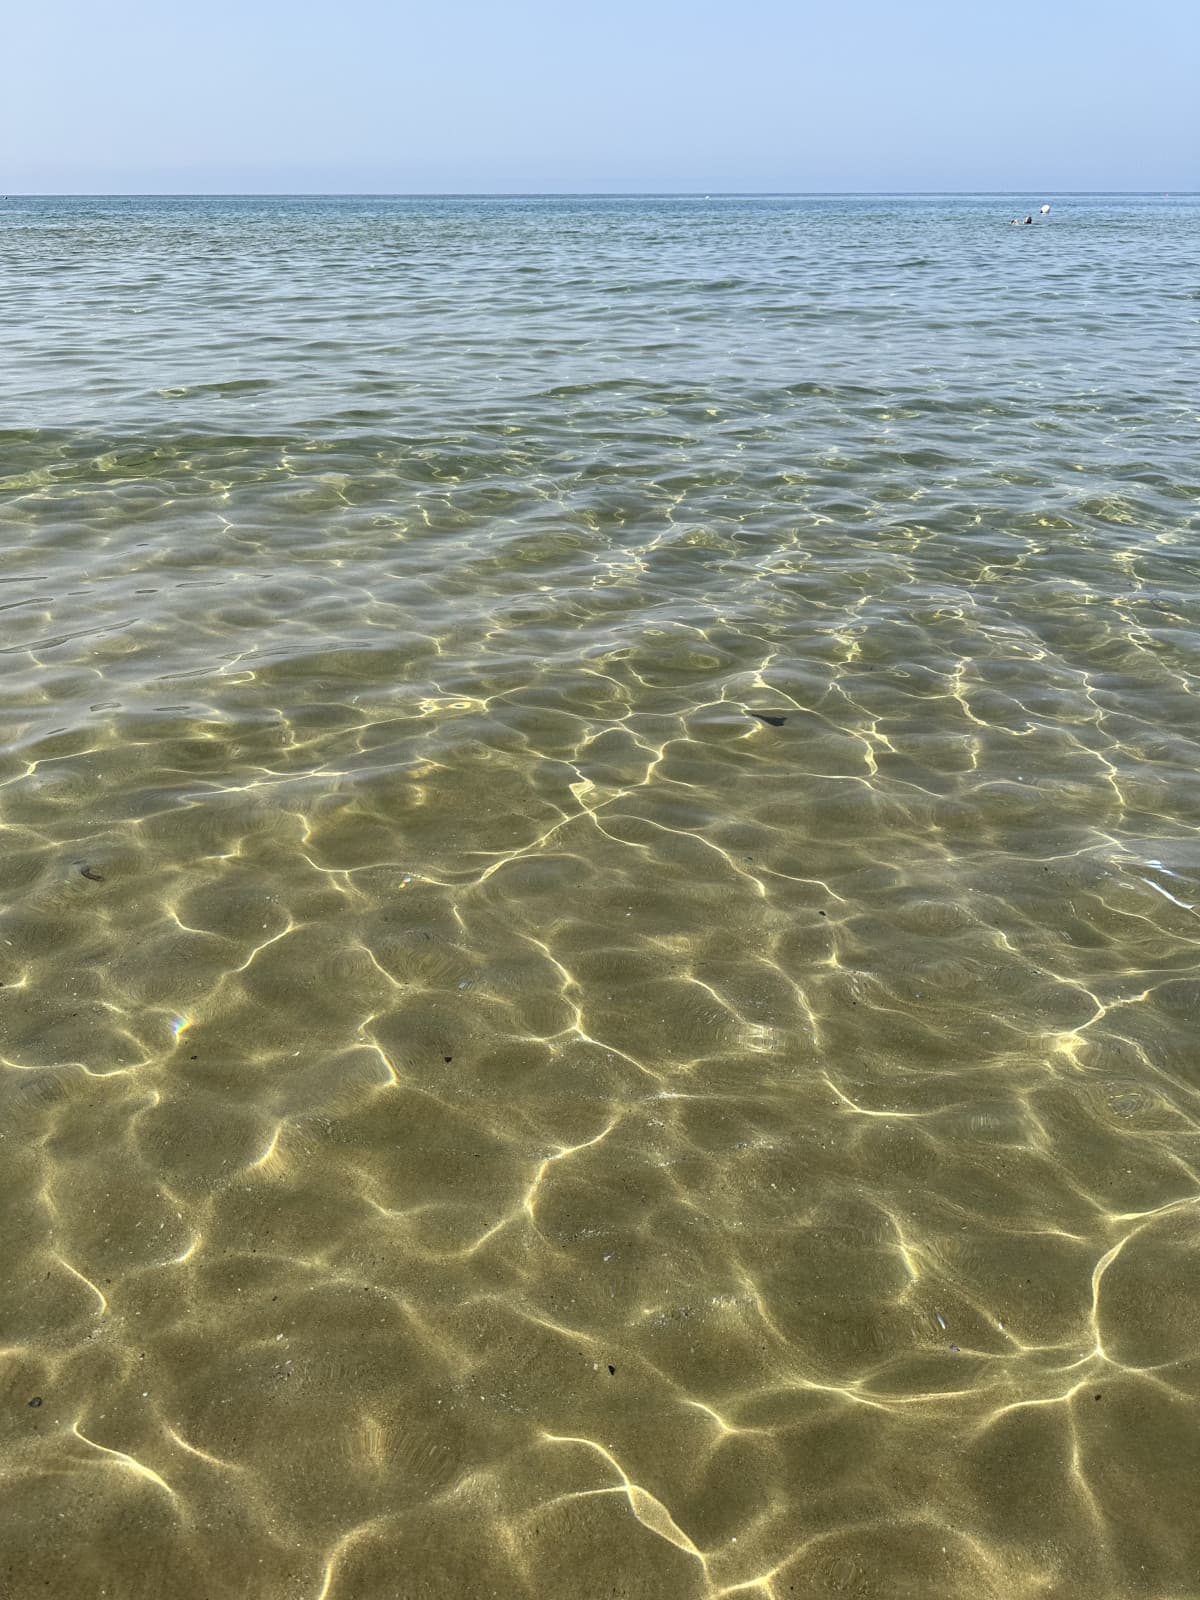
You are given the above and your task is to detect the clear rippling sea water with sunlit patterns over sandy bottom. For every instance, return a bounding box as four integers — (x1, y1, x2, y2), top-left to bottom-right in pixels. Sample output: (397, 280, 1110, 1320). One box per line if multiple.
(0, 197, 1200, 1600)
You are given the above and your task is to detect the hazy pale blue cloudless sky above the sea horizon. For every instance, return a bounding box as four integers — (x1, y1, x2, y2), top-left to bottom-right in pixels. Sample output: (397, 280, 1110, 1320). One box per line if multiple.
(0, 0, 1200, 195)
